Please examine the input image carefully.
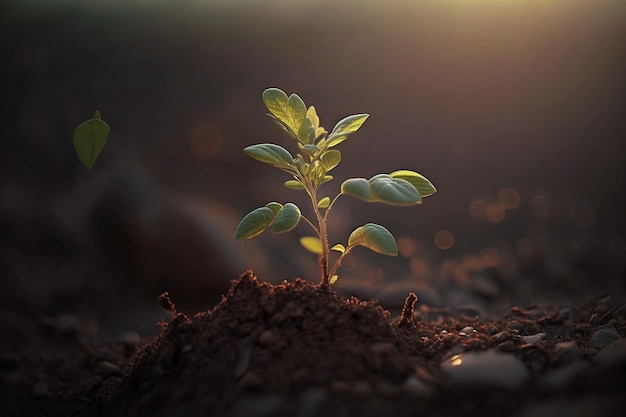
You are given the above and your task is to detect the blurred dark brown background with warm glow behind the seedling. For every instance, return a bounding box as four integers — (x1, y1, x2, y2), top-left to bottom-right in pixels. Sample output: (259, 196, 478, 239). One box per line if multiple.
(0, 0, 626, 328)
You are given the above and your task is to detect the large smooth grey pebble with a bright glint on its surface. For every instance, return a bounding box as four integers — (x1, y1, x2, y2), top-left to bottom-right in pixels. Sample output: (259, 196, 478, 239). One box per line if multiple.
(441, 351, 530, 389)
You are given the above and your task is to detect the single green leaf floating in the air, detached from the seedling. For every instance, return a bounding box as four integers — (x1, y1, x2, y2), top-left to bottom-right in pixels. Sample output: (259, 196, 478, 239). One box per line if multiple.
(72, 111, 111, 169)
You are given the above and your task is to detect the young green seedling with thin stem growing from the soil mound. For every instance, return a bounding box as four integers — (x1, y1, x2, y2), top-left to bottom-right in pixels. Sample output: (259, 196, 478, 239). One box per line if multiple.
(235, 88, 437, 291)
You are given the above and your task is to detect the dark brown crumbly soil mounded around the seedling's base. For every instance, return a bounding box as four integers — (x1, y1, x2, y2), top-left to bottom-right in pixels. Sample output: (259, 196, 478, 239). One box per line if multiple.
(2, 271, 626, 416)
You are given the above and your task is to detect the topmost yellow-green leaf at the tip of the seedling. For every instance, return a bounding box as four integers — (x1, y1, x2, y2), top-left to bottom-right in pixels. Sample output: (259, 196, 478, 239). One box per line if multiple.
(263, 88, 308, 143)
